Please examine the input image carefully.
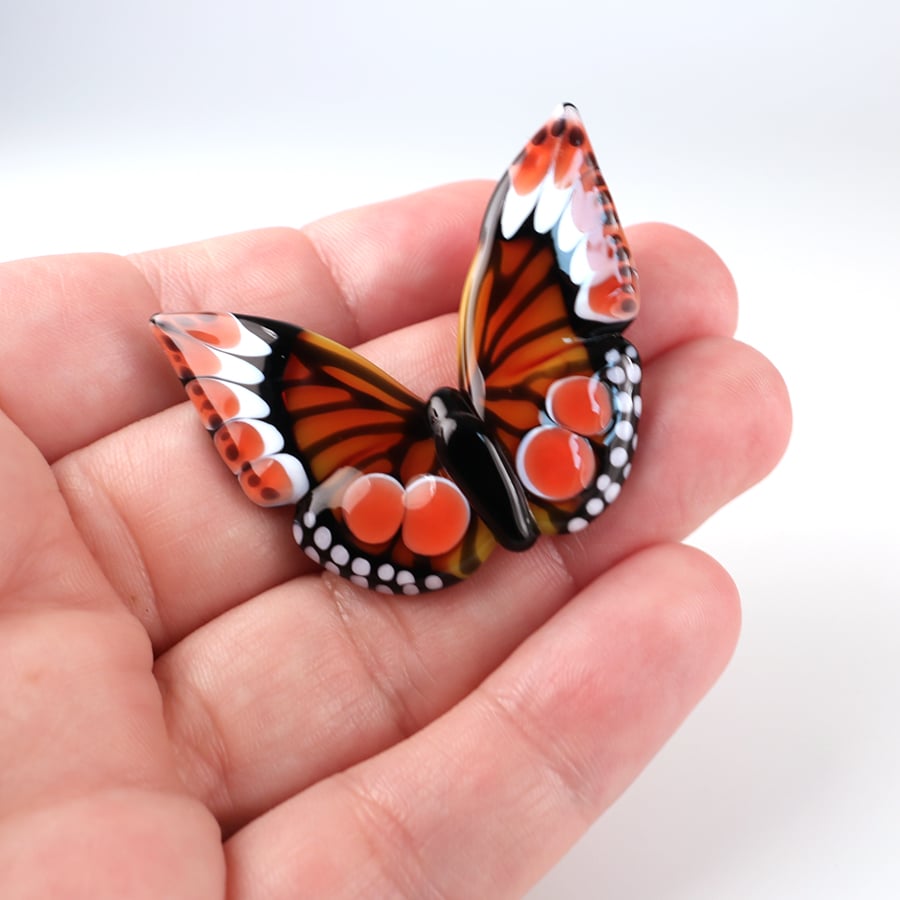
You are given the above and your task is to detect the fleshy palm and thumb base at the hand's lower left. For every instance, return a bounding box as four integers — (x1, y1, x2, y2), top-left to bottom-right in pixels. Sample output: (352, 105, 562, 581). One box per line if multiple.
(0, 414, 221, 897)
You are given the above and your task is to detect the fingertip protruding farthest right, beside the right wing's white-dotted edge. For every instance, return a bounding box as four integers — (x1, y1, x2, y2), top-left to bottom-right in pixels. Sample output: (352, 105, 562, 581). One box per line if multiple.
(557, 330, 791, 572)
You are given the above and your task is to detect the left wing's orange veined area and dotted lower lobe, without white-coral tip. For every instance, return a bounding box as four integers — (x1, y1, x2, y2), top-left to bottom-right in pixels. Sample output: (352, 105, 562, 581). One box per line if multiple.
(280, 330, 495, 593)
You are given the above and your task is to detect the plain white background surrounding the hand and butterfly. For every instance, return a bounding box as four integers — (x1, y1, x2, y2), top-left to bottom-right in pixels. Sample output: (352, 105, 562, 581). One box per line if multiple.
(0, 0, 900, 900)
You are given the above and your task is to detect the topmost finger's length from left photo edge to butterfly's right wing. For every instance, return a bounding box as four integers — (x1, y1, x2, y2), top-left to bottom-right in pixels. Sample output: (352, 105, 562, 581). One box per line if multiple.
(0, 183, 487, 460)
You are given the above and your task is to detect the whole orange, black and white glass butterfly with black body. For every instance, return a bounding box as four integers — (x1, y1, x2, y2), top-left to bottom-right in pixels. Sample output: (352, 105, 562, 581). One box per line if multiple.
(151, 104, 641, 594)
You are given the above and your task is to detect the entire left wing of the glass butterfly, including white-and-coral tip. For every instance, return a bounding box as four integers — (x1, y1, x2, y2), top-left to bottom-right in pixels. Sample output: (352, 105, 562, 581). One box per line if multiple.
(152, 313, 495, 594)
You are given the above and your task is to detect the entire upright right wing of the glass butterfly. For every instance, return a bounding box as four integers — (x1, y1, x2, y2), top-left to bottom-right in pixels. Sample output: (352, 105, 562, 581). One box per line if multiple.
(460, 105, 641, 533)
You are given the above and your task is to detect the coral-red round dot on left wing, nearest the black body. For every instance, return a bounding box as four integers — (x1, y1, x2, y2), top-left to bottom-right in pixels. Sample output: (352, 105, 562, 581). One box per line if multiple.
(403, 475, 471, 556)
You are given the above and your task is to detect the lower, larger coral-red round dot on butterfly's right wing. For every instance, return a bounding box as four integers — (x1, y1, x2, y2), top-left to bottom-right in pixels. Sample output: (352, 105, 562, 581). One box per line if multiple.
(516, 425, 597, 500)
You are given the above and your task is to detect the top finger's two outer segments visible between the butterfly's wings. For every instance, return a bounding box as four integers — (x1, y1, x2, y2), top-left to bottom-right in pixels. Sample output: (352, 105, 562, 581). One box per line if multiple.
(132, 182, 488, 346)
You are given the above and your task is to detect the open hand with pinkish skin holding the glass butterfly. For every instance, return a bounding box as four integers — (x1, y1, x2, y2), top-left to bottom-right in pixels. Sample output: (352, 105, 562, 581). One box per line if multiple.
(0, 184, 790, 898)
